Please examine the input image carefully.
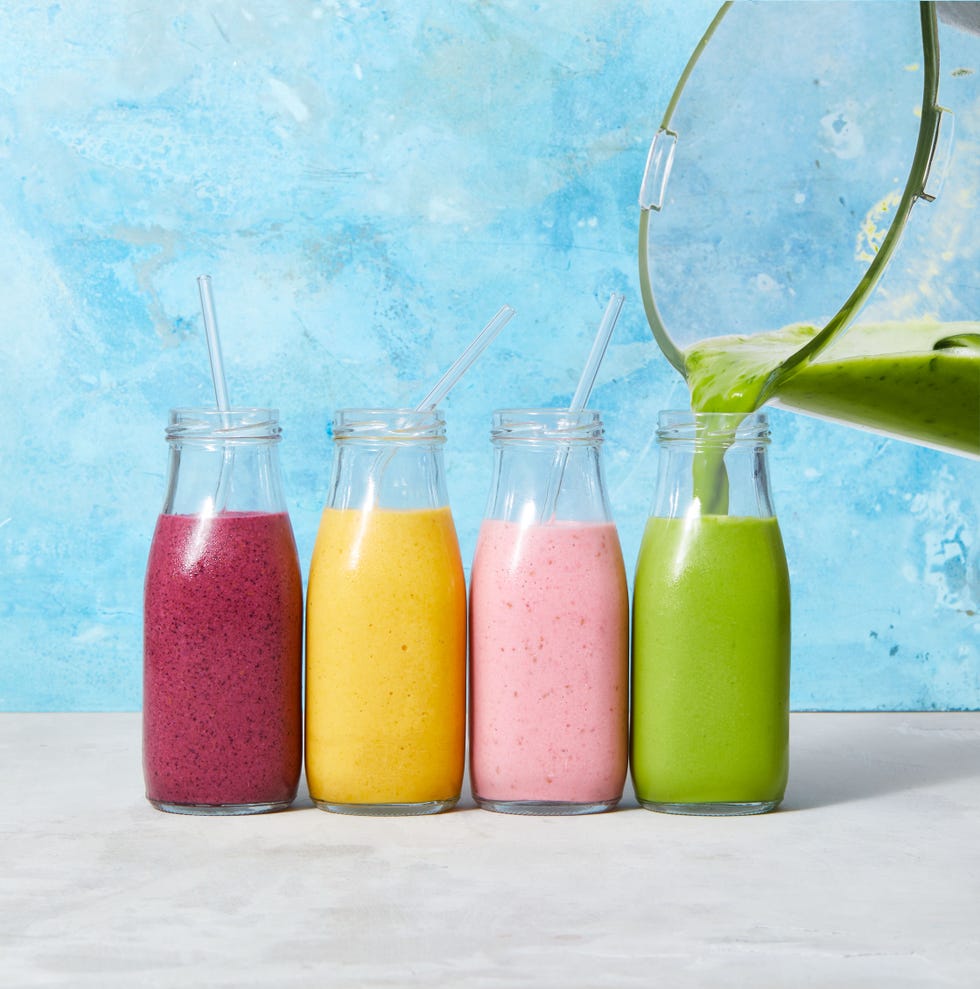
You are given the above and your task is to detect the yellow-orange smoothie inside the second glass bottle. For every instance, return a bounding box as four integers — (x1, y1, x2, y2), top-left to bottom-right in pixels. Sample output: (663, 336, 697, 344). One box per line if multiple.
(306, 508, 466, 809)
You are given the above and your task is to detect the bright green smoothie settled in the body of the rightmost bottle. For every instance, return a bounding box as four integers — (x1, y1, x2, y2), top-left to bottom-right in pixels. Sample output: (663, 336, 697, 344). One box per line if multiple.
(630, 515, 790, 813)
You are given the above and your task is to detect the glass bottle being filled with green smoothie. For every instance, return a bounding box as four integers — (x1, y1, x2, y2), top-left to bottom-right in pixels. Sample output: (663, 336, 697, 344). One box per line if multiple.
(630, 412, 790, 816)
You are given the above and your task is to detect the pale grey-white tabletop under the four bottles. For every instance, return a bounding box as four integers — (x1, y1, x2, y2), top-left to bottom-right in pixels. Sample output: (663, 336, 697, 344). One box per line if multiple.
(0, 713, 980, 989)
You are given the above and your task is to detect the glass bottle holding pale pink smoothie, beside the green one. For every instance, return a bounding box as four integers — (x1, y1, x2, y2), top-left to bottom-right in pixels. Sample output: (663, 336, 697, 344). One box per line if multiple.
(470, 409, 629, 815)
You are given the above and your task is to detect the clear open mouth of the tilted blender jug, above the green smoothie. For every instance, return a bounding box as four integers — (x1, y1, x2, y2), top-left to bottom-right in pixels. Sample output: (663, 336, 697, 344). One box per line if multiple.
(640, 0, 951, 372)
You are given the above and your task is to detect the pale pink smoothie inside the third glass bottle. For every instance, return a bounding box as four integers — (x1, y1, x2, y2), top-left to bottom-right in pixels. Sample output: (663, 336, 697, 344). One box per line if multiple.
(470, 520, 629, 805)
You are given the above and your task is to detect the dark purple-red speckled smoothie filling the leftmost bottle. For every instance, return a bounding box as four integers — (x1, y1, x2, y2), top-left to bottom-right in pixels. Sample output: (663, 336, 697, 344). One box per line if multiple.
(143, 512, 303, 805)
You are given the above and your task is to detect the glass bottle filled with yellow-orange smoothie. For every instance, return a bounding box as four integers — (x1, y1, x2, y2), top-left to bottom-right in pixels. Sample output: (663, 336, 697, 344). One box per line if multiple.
(306, 409, 466, 816)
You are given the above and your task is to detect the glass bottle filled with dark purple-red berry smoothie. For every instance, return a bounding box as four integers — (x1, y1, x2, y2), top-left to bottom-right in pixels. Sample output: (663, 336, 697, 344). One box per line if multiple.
(143, 409, 303, 815)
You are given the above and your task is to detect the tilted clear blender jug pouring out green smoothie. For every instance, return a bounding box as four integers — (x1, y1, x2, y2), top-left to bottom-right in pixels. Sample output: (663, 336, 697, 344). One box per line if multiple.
(639, 2, 980, 457)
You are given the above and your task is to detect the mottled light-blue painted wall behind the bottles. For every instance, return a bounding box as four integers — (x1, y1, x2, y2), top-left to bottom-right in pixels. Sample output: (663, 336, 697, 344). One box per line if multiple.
(0, 0, 980, 710)
